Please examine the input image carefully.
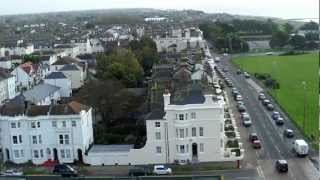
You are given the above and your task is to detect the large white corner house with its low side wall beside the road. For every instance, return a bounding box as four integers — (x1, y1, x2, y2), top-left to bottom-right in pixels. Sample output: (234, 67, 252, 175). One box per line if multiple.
(84, 89, 244, 165)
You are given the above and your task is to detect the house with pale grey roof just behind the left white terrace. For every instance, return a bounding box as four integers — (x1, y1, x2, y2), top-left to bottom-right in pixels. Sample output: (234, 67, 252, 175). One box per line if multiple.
(23, 83, 60, 105)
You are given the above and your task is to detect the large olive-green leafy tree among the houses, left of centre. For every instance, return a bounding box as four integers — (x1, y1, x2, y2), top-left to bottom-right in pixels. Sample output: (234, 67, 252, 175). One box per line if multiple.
(97, 48, 143, 87)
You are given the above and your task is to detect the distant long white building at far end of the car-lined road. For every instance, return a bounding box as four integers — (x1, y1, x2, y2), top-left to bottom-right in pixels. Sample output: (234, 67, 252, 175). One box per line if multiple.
(154, 28, 206, 52)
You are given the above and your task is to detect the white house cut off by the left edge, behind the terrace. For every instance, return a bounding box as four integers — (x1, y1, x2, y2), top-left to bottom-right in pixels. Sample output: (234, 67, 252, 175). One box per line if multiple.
(0, 68, 16, 104)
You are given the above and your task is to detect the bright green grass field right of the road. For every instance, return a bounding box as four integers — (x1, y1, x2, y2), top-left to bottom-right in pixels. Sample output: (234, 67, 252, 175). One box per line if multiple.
(233, 53, 319, 141)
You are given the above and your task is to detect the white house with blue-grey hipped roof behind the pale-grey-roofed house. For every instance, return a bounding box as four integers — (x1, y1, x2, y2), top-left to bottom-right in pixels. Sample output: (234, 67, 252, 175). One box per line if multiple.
(44, 72, 72, 97)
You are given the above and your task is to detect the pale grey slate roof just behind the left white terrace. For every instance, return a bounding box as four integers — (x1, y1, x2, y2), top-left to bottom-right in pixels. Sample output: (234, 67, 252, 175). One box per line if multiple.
(23, 83, 60, 103)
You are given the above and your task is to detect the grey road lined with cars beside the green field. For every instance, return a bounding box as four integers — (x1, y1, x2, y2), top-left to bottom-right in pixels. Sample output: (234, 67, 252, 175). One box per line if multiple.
(218, 53, 320, 180)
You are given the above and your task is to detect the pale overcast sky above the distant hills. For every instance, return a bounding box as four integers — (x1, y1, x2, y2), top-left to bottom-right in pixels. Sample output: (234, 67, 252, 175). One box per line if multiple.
(0, 0, 319, 18)
